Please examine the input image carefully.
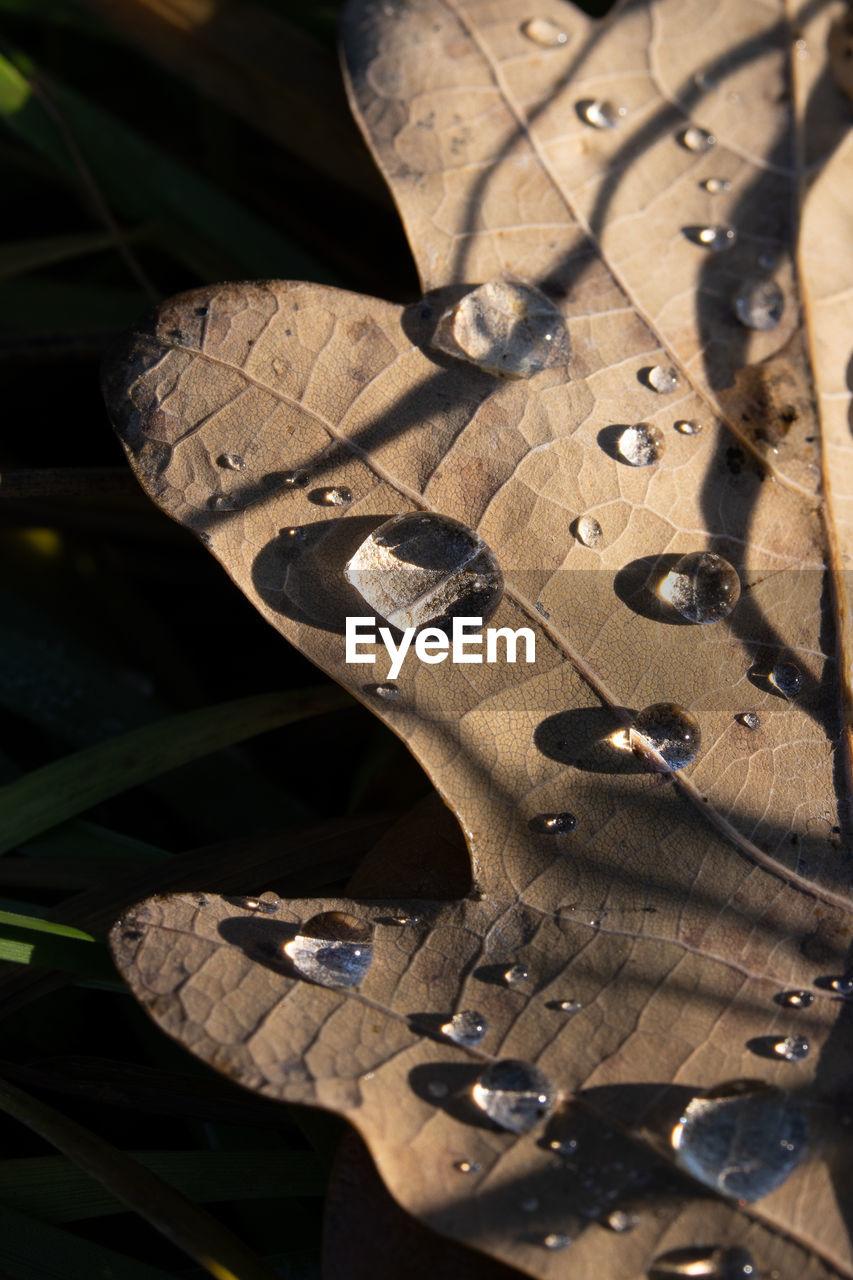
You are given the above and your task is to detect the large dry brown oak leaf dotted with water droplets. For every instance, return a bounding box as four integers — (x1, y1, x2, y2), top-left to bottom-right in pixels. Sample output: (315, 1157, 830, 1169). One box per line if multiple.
(106, 0, 853, 1280)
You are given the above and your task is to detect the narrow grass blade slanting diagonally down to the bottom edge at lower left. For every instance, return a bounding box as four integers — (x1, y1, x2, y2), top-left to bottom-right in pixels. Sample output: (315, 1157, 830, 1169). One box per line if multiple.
(0, 1080, 281, 1280)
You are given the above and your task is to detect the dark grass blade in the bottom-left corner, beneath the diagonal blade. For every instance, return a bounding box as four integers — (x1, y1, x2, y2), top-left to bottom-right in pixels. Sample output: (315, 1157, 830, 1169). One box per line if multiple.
(0, 1204, 174, 1280)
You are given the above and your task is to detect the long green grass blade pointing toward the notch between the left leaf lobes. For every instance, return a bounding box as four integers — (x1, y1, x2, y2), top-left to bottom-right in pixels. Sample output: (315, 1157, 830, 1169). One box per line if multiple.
(0, 689, 352, 852)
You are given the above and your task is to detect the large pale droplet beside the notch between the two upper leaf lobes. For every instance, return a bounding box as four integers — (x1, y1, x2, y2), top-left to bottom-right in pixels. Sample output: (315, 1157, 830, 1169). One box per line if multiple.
(433, 280, 571, 378)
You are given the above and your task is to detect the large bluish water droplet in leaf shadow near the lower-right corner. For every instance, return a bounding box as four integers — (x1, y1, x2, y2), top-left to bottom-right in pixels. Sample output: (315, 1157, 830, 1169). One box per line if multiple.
(671, 1082, 808, 1202)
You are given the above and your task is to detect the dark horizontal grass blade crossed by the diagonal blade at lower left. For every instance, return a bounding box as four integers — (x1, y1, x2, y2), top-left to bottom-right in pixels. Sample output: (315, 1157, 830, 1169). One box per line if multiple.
(0, 1151, 325, 1222)
